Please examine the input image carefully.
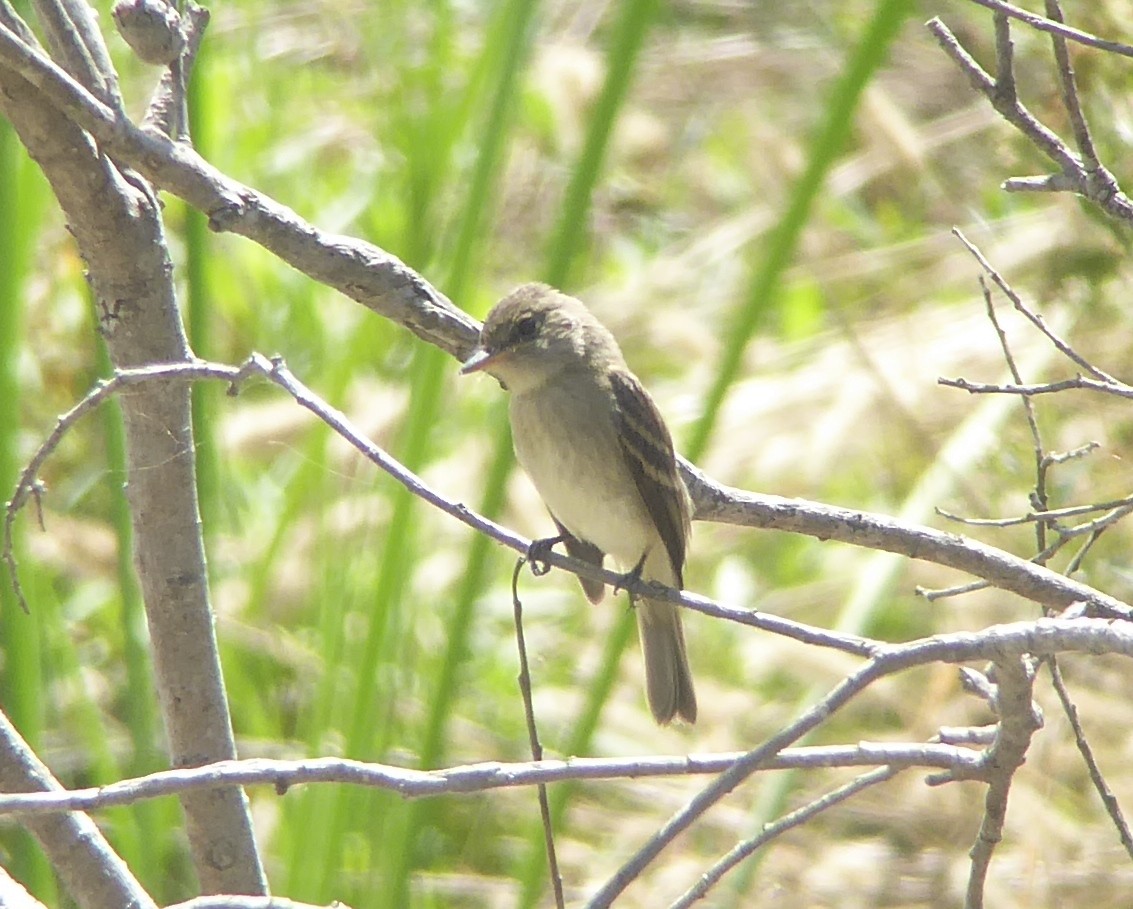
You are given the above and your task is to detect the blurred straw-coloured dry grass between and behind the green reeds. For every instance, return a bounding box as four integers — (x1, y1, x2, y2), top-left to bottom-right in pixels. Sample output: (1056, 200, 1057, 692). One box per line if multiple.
(11, 0, 1133, 909)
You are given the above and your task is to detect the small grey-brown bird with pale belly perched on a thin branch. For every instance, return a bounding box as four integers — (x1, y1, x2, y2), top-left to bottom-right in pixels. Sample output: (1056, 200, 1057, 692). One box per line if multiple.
(461, 283, 697, 725)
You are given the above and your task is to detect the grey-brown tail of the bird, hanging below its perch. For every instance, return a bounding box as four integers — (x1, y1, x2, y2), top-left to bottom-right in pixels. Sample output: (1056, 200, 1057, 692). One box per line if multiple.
(637, 600, 697, 725)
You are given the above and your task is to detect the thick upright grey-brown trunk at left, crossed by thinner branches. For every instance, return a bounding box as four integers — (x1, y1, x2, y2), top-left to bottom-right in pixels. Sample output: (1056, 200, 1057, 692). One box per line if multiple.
(0, 2, 266, 904)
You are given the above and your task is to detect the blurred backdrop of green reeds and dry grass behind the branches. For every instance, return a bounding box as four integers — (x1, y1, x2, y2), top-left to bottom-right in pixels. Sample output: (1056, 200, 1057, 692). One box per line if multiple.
(0, 0, 1133, 909)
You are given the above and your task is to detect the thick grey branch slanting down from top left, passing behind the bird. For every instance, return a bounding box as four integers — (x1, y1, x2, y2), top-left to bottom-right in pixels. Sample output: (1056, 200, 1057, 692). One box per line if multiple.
(0, 19, 1128, 614)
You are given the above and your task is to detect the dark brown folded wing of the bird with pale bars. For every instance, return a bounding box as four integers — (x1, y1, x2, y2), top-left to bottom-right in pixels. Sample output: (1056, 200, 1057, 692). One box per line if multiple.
(610, 369, 689, 587)
